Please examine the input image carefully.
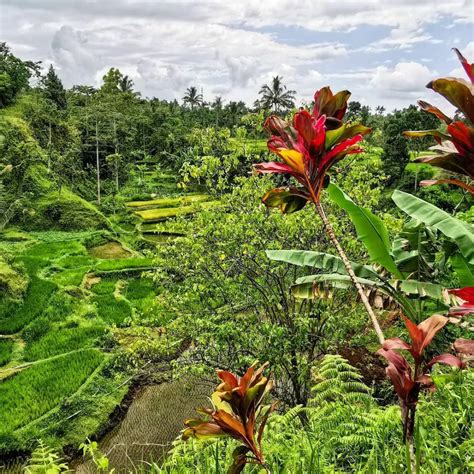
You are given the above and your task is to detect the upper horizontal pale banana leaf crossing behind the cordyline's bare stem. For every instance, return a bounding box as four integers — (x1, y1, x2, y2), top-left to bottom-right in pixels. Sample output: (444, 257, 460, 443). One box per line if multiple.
(265, 250, 380, 278)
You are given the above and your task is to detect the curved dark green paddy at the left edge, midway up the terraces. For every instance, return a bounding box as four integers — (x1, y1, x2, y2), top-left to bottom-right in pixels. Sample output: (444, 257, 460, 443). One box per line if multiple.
(0, 276, 57, 334)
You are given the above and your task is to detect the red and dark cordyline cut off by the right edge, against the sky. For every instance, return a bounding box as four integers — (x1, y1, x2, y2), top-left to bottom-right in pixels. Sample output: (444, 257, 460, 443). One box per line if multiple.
(404, 48, 474, 193)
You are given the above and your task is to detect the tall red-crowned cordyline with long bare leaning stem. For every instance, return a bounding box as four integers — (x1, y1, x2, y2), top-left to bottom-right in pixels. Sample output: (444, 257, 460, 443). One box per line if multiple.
(255, 87, 384, 343)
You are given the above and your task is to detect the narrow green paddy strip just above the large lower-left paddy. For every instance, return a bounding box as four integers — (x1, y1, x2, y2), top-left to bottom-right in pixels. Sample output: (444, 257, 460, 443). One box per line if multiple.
(24, 324, 104, 361)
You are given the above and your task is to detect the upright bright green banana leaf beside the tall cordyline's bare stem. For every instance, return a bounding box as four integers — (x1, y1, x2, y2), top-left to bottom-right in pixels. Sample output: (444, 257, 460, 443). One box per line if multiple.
(328, 184, 403, 278)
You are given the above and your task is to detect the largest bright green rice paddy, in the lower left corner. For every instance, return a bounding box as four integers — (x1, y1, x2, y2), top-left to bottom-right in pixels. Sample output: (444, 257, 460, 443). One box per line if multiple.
(0, 350, 103, 433)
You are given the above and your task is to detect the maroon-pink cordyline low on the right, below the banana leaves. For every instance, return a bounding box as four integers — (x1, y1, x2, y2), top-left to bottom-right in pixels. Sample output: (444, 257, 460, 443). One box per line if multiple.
(377, 314, 463, 444)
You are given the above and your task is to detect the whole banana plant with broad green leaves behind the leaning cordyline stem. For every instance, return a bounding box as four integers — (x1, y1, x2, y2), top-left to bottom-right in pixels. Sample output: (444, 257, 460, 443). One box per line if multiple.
(267, 184, 474, 321)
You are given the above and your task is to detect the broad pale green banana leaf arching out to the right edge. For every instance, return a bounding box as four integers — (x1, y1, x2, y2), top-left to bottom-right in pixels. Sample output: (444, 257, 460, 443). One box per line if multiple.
(392, 189, 474, 265)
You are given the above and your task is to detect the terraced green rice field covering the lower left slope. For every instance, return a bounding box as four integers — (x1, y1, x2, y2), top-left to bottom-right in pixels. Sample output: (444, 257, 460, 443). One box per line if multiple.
(0, 233, 156, 454)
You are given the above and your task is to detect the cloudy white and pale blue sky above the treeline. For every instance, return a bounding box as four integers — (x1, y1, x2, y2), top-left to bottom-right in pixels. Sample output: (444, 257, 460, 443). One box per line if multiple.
(0, 0, 474, 109)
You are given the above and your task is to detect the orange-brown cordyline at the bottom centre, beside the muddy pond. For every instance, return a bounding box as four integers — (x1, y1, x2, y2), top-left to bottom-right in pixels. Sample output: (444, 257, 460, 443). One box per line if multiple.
(182, 364, 276, 474)
